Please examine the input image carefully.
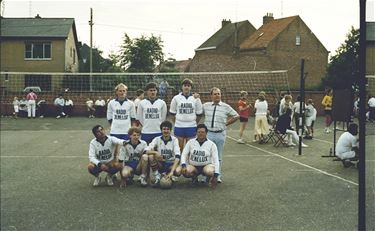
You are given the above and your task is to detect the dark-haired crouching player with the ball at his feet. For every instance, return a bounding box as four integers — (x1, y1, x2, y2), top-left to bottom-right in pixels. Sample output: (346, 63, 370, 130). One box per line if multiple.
(146, 121, 181, 185)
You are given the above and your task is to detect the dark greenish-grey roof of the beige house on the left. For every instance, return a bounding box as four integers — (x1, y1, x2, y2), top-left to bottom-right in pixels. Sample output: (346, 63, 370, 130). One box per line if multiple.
(1, 18, 75, 38)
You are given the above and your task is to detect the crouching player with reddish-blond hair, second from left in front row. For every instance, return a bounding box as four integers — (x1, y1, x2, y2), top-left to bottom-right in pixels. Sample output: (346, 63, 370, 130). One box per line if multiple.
(119, 127, 148, 187)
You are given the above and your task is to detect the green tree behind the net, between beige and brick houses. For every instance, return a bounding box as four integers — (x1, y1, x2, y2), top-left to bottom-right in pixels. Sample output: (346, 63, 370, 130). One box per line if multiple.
(119, 33, 164, 72)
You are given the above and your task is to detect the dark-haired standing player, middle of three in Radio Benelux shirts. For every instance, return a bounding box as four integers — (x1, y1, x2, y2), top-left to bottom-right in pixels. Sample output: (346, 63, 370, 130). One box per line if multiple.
(137, 82, 168, 144)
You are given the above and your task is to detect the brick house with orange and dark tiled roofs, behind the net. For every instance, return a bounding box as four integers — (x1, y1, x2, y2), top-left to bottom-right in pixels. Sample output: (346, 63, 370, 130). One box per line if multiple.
(189, 14, 328, 89)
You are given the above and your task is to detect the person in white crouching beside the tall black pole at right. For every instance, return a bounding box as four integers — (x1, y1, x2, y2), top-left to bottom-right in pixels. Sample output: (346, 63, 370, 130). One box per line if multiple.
(336, 123, 358, 168)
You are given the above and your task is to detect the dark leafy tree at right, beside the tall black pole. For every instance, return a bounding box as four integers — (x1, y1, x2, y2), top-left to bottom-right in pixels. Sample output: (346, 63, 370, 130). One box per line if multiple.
(323, 27, 359, 89)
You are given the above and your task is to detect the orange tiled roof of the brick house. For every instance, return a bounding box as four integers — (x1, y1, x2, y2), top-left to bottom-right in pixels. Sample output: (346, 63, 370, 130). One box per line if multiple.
(240, 16, 299, 50)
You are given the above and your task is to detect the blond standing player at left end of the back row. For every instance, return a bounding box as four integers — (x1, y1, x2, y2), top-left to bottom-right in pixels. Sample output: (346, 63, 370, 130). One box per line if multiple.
(107, 83, 135, 140)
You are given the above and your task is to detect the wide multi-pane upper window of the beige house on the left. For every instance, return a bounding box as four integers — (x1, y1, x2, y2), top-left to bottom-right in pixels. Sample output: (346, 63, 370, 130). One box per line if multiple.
(25, 42, 51, 59)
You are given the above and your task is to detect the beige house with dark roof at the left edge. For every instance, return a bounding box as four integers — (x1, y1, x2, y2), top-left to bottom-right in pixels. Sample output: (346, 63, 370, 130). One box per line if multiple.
(0, 15, 79, 91)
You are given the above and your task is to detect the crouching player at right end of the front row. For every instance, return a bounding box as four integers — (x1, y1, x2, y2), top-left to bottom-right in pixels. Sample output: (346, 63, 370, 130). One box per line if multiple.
(181, 124, 219, 188)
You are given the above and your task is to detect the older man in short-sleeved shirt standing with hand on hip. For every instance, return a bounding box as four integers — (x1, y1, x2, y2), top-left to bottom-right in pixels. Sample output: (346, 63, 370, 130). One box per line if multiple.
(203, 87, 240, 183)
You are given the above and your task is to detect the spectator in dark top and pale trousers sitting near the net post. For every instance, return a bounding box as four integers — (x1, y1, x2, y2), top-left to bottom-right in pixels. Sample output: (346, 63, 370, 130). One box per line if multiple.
(276, 108, 308, 148)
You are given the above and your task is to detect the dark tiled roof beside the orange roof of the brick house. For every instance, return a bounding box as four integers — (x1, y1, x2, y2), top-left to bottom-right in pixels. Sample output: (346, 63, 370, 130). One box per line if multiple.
(198, 20, 255, 49)
